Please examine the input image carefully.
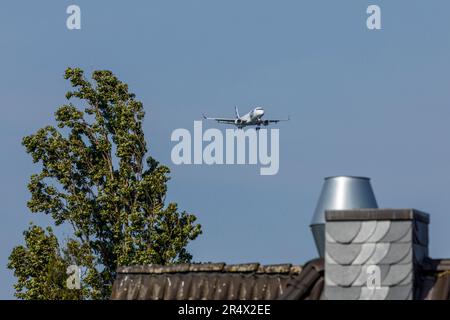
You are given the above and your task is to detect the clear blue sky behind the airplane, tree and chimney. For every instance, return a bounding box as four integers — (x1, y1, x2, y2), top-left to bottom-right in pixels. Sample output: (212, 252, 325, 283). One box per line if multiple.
(0, 0, 450, 298)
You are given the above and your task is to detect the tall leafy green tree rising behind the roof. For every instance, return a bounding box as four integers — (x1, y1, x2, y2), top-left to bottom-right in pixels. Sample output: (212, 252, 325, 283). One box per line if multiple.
(8, 68, 201, 299)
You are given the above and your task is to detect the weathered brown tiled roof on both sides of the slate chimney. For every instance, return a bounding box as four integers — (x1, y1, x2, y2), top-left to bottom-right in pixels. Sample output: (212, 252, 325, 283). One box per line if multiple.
(111, 259, 450, 300)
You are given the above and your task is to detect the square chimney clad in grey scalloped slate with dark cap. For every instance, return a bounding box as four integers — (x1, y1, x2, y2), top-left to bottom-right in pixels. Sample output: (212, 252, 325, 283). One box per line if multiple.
(324, 209, 429, 300)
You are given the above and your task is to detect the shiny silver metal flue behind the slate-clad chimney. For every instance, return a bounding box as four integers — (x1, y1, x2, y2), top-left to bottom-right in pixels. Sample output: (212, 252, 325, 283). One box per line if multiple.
(310, 176, 378, 257)
